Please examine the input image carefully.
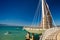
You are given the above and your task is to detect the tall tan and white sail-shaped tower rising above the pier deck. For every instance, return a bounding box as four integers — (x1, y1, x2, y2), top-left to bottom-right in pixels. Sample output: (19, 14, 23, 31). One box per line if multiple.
(41, 0, 52, 29)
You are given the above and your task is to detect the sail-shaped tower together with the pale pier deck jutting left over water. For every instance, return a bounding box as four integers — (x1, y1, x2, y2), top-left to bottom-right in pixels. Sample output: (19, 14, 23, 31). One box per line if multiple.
(24, 0, 52, 33)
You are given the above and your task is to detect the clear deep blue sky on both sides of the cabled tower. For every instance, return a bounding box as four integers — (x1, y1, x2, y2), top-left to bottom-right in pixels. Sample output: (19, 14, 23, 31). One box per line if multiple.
(0, 0, 60, 26)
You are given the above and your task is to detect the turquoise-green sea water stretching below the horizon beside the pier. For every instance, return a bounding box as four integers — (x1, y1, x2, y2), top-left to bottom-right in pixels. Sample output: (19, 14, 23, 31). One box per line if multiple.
(0, 26, 38, 40)
